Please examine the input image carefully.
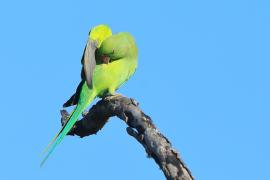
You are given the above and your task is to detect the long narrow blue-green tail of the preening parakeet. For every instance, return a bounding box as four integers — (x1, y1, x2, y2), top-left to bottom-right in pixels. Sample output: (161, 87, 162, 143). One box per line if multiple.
(40, 86, 95, 166)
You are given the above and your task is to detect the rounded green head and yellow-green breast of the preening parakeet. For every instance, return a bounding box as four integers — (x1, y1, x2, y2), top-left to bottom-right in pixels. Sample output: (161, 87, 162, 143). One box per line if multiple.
(93, 33, 138, 96)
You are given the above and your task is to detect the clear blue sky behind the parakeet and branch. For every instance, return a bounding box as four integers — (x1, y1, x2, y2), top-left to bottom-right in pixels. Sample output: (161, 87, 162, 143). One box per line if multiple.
(0, 0, 270, 180)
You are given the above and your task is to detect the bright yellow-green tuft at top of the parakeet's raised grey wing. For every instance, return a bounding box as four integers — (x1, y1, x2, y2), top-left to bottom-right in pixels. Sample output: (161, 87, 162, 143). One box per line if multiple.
(89, 24, 112, 48)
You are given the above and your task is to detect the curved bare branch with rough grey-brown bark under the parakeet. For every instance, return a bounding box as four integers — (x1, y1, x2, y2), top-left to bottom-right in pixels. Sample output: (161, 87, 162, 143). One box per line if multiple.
(61, 95, 194, 180)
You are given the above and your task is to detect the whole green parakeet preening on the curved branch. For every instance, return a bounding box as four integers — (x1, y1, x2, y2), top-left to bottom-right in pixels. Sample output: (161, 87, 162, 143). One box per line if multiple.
(41, 25, 138, 165)
